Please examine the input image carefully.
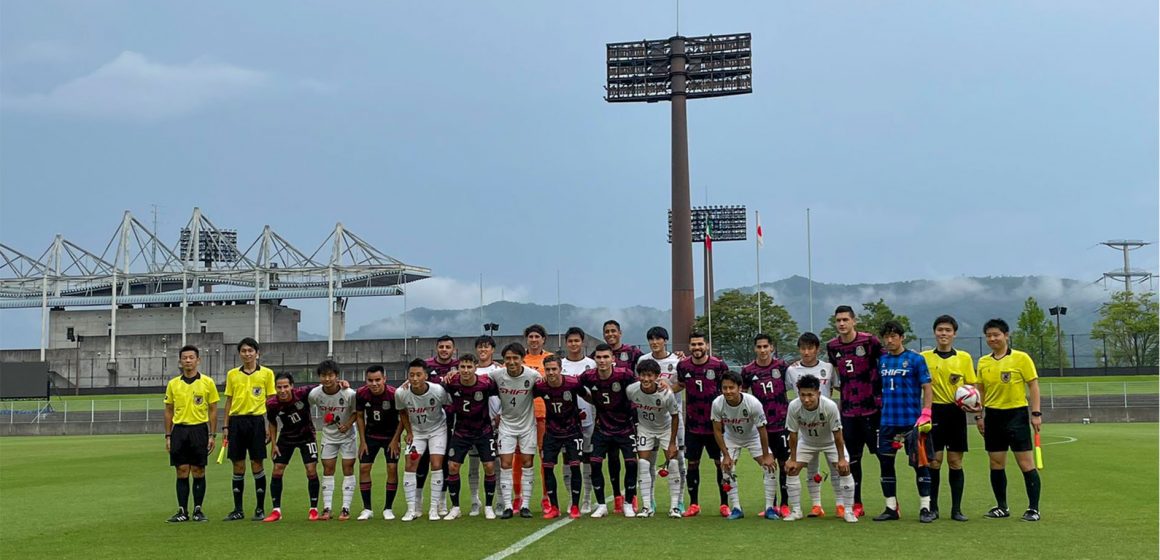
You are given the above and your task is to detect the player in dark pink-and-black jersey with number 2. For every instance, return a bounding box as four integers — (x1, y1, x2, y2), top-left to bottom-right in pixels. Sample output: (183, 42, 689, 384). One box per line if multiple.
(443, 354, 500, 521)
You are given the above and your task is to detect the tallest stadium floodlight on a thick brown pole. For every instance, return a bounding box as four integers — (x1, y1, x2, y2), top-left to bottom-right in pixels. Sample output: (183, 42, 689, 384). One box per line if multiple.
(604, 34, 753, 350)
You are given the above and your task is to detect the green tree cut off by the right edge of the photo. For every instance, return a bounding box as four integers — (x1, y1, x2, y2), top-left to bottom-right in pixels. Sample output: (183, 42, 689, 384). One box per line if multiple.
(1092, 291, 1160, 368)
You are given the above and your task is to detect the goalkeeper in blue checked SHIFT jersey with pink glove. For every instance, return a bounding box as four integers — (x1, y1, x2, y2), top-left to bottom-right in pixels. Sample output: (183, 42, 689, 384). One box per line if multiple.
(873, 321, 935, 523)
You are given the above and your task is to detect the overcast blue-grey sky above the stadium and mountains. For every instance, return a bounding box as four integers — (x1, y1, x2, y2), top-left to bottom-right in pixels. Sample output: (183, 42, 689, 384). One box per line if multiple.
(0, 0, 1158, 347)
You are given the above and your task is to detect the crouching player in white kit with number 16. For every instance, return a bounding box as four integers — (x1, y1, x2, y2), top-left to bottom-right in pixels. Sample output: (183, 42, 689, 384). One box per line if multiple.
(711, 371, 777, 519)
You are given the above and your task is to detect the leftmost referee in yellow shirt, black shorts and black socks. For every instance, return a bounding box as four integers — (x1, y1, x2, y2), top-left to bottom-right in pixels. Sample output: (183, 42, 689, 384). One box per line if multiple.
(165, 346, 219, 523)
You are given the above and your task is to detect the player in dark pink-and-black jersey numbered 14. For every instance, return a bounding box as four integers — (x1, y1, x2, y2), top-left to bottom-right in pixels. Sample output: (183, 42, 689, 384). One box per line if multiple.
(741, 334, 793, 519)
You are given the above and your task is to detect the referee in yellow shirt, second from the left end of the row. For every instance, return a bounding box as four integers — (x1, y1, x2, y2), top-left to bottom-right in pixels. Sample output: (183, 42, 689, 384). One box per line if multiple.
(222, 336, 275, 521)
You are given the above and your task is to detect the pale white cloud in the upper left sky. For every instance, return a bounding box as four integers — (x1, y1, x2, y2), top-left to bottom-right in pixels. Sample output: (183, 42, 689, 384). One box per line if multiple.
(3, 51, 268, 121)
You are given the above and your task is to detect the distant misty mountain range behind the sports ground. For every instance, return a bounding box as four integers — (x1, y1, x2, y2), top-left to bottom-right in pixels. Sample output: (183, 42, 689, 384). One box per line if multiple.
(322, 276, 1109, 346)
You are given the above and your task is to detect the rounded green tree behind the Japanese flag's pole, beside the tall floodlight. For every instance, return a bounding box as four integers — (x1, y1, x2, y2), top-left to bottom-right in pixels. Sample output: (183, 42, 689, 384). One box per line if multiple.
(693, 290, 798, 363)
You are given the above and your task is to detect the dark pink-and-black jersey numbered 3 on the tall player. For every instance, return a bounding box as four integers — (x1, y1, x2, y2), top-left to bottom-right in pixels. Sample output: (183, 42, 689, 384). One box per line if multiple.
(826, 333, 882, 416)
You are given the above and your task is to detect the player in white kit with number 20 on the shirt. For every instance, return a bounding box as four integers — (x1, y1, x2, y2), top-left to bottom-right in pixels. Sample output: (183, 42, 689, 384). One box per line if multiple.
(626, 358, 681, 518)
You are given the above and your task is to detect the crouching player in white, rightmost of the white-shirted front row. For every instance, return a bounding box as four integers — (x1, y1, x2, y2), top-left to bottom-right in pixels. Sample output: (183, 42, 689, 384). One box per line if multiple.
(782, 376, 858, 523)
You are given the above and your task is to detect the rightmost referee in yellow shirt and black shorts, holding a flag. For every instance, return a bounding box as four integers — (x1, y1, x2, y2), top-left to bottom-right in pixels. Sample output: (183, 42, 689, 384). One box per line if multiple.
(974, 319, 1043, 521)
